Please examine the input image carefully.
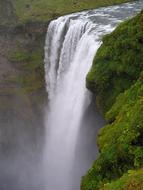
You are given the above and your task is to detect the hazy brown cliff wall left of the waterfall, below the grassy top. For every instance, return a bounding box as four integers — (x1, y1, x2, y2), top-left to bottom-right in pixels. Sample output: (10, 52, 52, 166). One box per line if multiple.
(0, 7, 47, 157)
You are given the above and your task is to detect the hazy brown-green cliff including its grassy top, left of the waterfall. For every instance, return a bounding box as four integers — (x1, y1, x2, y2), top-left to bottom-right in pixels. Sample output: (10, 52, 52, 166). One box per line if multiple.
(0, 0, 132, 156)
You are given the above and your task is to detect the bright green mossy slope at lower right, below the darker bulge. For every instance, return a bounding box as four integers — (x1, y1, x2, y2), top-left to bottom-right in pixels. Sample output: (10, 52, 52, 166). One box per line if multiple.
(82, 75, 143, 190)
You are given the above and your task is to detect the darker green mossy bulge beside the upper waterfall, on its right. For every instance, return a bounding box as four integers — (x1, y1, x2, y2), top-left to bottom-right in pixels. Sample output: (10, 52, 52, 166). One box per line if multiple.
(87, 13, 143, 111)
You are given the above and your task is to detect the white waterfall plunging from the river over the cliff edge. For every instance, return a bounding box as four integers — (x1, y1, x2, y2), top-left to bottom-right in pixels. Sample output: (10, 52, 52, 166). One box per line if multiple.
(44, 1, 143, 190)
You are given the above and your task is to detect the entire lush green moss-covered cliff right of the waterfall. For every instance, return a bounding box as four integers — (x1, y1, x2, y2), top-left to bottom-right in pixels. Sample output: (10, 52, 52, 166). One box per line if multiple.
(81, 12, 143, 190)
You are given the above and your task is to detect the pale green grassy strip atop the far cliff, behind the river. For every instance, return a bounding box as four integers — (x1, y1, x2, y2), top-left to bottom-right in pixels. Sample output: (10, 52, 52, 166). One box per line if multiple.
(12, 0, 132, 23)
